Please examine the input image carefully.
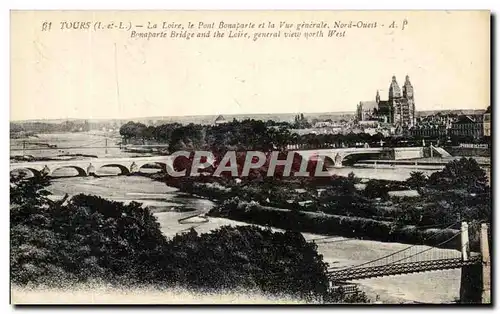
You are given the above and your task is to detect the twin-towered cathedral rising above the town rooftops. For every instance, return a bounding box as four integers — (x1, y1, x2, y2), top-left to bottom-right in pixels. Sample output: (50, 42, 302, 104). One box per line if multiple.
(356, 75, 415, 127)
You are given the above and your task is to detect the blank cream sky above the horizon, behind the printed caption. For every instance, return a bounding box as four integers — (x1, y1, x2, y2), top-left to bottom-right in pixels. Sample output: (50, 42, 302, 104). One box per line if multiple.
(10, 11, 490, 120)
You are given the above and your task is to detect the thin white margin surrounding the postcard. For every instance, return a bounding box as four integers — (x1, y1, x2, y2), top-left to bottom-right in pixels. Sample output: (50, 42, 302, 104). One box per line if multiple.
(0, 0, 500, 313)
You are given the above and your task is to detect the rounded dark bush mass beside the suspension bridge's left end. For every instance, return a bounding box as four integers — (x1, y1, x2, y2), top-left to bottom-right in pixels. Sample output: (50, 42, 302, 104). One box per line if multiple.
(169, 226, 328, 299)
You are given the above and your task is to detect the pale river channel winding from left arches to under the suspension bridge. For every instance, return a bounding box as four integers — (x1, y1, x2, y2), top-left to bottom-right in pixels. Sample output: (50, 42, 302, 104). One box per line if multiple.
(49, 176, 460, 303)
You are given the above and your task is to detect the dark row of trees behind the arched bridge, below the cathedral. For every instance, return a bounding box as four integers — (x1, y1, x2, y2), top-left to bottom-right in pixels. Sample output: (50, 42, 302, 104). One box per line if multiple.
(120, 117, 421, 151)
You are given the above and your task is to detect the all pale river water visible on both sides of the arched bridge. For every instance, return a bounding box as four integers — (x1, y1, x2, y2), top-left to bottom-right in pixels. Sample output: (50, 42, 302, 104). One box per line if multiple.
(11, 133, 460, 303)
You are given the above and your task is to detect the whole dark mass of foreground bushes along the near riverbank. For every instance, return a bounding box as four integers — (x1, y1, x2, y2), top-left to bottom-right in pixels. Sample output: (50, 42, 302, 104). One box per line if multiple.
(10, 178, 367, 302)
